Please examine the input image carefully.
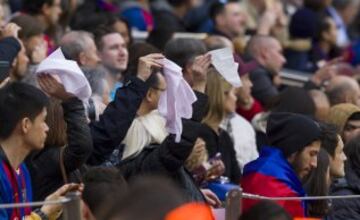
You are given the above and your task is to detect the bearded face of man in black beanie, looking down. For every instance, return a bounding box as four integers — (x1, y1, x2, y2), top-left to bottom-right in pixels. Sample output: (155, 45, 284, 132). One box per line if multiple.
(289, 141, 321, 180)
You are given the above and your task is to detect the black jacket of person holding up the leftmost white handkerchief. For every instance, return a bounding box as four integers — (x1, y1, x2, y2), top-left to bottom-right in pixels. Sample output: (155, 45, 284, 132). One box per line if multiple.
(26, 98, 92, 201)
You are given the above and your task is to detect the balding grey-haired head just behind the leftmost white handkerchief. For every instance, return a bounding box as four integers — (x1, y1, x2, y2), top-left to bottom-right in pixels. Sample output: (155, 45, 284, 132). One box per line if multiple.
(60, 31, 100, 67)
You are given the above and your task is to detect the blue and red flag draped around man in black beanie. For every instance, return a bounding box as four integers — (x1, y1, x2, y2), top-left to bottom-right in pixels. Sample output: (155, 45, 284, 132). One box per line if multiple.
(241, 146, 307, 217)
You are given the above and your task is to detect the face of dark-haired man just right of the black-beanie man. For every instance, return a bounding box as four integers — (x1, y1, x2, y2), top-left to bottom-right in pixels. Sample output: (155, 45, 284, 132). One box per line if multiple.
(330, 136, 346, 178)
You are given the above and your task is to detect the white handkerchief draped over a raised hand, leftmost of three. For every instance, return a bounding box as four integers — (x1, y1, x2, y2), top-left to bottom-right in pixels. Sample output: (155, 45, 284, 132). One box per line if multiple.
(36, 48, 92, 102)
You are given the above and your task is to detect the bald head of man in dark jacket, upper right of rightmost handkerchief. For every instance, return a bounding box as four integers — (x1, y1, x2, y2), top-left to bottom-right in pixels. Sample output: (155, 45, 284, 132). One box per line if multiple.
(246, 35, 286, 73)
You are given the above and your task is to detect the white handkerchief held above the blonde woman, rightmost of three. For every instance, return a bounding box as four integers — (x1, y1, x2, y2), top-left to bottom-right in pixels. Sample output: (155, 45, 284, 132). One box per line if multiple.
(209, 48, 242, 88)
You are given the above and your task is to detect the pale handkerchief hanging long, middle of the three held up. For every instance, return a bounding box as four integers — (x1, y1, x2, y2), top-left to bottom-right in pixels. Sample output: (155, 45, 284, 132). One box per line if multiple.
(158, 59, 197, 143)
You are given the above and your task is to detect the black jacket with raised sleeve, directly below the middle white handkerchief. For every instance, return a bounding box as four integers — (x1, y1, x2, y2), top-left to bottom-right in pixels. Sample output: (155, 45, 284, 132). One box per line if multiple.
(119, 120, 204, 202)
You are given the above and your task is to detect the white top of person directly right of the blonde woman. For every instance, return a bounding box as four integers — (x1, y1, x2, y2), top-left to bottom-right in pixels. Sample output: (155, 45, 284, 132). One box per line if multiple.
(221, 113, 259, 170)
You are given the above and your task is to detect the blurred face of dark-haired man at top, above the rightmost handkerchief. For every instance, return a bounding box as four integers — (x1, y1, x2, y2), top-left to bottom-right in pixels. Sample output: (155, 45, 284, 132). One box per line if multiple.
(224, 2, 246, 37)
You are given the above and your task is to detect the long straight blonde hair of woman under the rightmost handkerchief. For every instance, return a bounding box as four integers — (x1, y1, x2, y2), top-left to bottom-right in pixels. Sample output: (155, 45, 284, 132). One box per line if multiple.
(203, 67, 232, 126)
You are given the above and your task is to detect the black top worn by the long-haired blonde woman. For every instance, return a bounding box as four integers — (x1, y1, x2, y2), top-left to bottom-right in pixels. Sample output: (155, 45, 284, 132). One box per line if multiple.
(200, 124, 241, 184)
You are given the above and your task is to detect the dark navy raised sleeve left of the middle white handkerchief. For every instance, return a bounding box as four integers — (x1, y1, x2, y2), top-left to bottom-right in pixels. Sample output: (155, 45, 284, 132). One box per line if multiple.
(88, 76, 149, 165)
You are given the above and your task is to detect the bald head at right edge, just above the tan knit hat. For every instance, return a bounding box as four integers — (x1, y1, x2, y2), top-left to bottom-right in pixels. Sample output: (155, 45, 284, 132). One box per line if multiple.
(326, 76, 360, 106)
